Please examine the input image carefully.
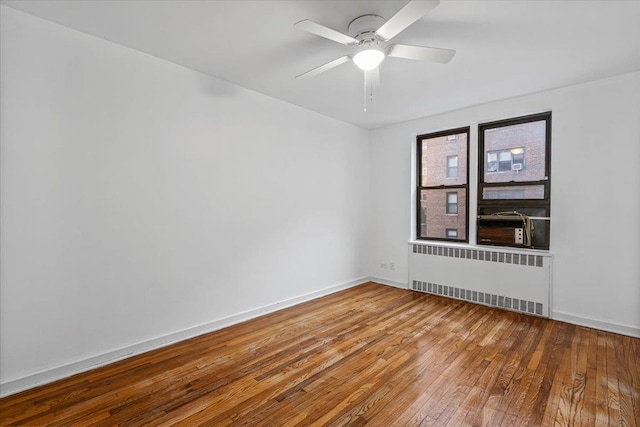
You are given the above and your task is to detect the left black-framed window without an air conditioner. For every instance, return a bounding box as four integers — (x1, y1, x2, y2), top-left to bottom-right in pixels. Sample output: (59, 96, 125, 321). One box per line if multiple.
(416, 128, 469, 242)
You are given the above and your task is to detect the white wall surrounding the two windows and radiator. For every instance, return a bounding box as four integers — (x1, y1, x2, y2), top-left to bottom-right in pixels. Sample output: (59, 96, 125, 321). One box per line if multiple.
(370, 72, 640, 336)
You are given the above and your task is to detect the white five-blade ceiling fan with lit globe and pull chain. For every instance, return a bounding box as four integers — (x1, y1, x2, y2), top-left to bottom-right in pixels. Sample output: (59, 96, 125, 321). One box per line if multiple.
(294, 0, 456, 88)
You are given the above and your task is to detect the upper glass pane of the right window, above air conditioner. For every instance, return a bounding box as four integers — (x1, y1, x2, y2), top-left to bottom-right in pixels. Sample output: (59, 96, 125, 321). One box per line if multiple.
(484, 120, 546, 183)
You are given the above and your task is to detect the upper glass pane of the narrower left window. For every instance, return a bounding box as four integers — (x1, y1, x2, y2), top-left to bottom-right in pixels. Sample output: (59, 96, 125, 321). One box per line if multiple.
(421, 132, 467, 187)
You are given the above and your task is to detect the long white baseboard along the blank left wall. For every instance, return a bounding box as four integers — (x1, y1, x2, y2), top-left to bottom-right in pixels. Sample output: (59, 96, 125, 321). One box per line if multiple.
(0, 277, 370, 397)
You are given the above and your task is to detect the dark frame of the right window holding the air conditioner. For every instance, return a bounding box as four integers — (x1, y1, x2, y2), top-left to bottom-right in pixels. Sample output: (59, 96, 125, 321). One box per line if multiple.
(476, 111, 552, 250)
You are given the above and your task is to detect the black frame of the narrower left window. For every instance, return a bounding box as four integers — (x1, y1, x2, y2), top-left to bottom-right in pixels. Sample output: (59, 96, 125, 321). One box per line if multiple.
(415, 126, 471, 243)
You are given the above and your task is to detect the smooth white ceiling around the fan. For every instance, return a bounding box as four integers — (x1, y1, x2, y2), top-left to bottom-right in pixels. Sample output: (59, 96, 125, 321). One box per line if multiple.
(2, 0, 640, 129)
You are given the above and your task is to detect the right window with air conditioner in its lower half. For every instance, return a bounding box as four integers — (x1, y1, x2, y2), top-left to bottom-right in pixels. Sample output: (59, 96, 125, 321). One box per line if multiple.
(478, 113, 551, 249)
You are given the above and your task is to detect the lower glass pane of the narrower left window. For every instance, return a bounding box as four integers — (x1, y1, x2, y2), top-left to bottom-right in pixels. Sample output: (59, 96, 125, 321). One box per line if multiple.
(418, 188, 467, 240)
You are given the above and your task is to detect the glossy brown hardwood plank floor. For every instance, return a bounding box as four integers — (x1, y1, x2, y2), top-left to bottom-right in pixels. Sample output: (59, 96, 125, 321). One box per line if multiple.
(0, 283, 640, 426)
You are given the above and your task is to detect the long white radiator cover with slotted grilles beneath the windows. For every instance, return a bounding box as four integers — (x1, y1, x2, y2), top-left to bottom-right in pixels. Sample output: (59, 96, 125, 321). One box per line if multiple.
(409, 243, 552, 317)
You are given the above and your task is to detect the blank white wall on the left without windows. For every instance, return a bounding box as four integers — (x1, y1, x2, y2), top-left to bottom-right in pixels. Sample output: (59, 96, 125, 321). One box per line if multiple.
(0, 6, 369, 392)
